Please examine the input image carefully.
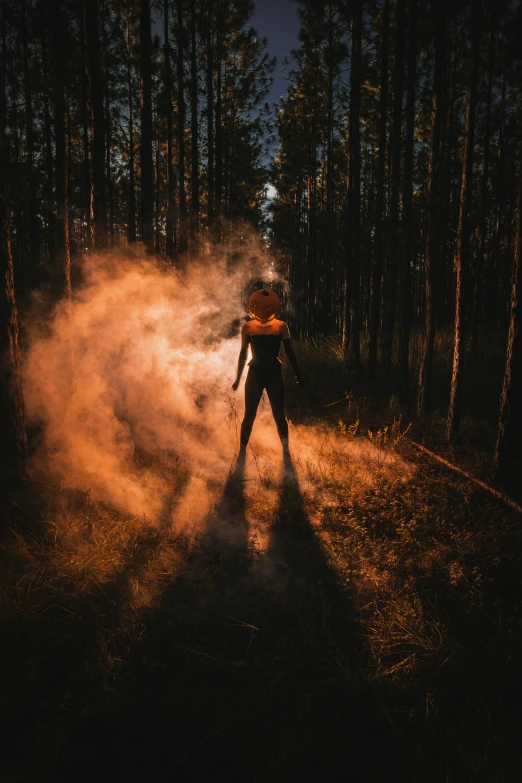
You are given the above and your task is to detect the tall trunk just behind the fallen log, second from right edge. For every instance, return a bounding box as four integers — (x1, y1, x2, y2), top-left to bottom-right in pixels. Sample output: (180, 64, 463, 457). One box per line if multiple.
(446, 0, 481, 440)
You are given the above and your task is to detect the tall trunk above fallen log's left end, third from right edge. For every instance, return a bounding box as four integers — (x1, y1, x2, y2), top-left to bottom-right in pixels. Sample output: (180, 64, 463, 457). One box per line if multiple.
(417, 0, 446, 414)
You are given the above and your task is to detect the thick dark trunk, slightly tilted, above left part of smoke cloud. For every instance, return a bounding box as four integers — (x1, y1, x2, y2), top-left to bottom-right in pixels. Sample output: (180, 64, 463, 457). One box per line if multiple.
(84, 0, 108, 250)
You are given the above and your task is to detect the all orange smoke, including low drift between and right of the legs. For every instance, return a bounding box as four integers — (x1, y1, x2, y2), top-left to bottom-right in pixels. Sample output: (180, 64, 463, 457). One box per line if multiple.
(24, 240, 409, 532)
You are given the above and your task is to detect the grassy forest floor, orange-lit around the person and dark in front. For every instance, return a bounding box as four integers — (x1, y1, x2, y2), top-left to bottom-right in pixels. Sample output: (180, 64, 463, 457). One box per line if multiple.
(0, 336, 522, 783)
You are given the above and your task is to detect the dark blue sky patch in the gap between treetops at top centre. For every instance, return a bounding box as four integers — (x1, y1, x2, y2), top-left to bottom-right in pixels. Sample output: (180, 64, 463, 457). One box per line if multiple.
(250, 0, 299, 103)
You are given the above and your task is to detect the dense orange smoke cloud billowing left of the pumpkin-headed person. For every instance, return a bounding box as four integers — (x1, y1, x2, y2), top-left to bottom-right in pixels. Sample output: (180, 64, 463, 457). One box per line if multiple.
(23, 241, 273, 519)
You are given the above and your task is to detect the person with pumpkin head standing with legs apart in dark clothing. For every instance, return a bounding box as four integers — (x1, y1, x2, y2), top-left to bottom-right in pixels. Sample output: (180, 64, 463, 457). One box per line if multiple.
(232, 288, 303, 450)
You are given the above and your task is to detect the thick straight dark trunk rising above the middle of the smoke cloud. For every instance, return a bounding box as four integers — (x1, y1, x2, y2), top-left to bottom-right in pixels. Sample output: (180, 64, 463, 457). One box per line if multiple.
(140, 0, 154, 252)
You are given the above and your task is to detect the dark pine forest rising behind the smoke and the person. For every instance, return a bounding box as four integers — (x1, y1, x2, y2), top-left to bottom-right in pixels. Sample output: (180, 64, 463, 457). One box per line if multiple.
(0, 0, 522, 486)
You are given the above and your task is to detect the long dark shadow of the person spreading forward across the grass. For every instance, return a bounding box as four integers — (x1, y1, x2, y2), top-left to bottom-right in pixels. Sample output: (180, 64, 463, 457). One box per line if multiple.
(46, 453, 408, 783)
